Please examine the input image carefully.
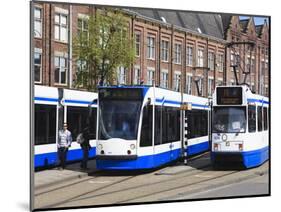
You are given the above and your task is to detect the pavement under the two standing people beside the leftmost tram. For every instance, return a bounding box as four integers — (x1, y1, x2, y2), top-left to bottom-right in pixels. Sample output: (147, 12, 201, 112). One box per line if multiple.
(34, 159, 97, 189)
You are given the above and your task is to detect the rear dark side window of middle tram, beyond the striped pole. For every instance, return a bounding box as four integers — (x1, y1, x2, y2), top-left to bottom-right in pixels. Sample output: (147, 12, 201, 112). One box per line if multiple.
(187, 110, 208, 138)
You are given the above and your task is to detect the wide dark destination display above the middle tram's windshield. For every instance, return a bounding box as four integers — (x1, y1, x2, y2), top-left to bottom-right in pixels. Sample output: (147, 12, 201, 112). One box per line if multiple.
(99, 88, 142, 100)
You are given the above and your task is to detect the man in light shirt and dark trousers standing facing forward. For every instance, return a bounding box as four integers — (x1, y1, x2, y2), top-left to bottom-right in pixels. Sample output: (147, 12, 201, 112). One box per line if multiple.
(58, 123, 72, 170)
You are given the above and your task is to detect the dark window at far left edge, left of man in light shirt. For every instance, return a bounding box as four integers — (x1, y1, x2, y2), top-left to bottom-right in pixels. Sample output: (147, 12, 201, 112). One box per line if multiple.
(34, 104, 56, 145)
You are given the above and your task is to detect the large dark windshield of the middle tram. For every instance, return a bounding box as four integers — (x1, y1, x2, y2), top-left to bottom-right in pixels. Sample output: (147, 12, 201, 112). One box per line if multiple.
(99, 100, 142, 140)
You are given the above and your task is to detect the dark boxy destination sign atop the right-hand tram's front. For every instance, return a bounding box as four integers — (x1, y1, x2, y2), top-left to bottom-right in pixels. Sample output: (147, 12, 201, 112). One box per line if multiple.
(217, 87, 242, 105)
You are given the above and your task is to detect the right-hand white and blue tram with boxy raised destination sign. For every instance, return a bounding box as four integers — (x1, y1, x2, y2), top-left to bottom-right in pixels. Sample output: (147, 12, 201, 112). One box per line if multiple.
(211, 85, 269, 168)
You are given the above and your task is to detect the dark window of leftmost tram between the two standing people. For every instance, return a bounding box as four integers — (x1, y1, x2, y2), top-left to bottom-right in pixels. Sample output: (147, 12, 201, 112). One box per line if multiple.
(67, 106, 89, 141)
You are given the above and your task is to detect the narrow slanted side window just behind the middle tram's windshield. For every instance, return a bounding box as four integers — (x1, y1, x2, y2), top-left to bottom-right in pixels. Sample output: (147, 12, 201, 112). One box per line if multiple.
(140, 105, 152, 147)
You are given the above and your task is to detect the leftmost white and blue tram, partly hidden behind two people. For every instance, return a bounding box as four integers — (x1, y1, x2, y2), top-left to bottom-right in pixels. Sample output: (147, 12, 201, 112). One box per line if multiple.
(34, 85, 97, 168)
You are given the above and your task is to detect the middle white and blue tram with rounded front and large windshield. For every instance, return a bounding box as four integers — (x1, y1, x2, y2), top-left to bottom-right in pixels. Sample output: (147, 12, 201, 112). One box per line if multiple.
(96, 86, 210, 170)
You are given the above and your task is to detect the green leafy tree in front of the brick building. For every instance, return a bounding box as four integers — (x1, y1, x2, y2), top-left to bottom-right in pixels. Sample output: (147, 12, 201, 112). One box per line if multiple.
(73, 9, 135, 91)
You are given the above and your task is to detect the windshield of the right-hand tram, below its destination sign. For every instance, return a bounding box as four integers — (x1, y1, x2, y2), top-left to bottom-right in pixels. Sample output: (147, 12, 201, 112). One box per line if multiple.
(212, 107, 246, 133)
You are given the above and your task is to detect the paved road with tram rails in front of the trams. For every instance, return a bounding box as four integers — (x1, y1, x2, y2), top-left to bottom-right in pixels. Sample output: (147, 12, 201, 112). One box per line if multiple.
(35, 154, 268, 208)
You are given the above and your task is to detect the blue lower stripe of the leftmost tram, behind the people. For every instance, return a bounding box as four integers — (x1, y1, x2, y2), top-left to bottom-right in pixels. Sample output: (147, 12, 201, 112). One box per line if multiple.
(34, 147, 96, 167)
